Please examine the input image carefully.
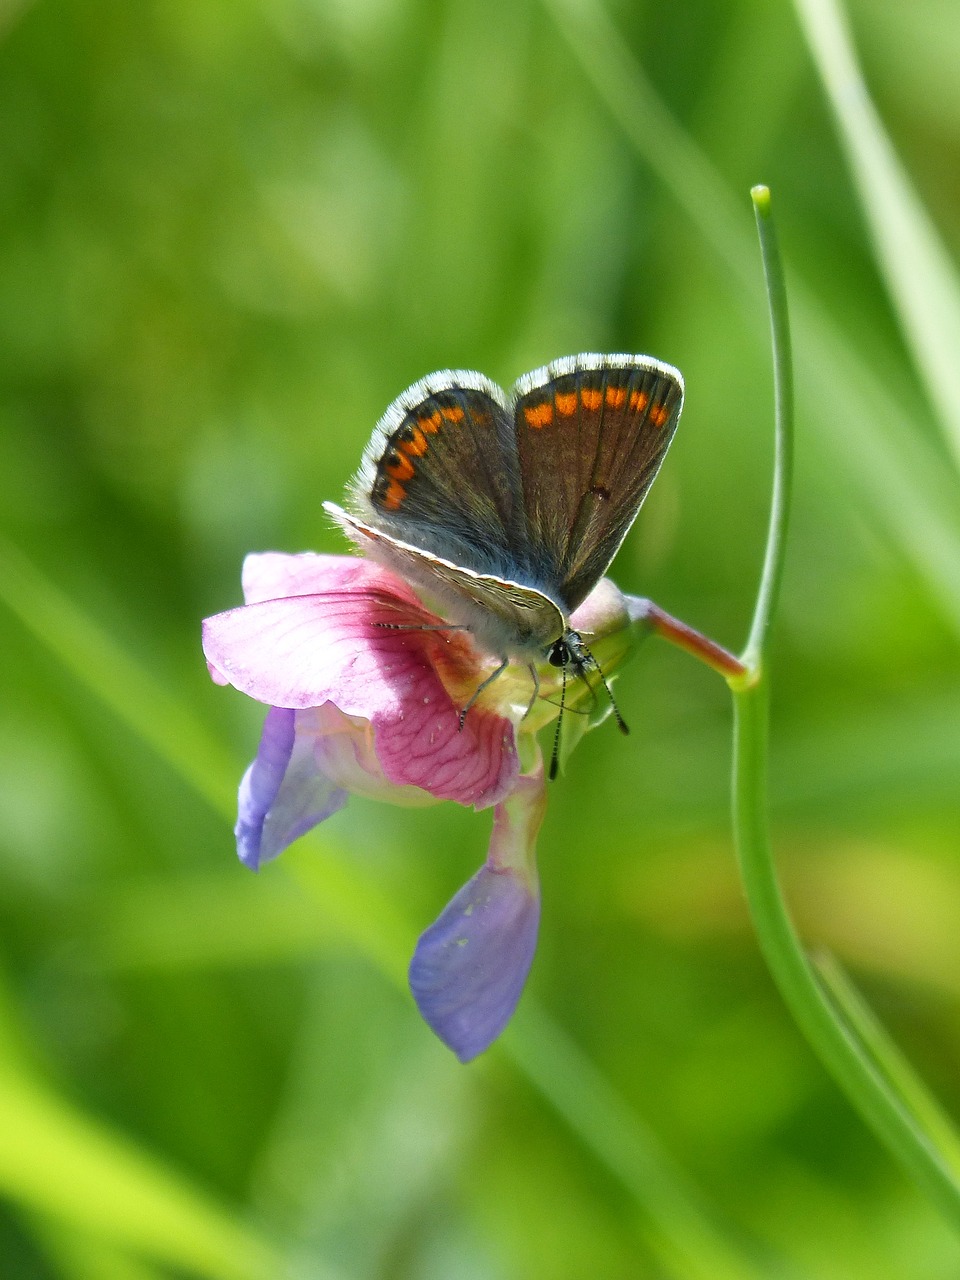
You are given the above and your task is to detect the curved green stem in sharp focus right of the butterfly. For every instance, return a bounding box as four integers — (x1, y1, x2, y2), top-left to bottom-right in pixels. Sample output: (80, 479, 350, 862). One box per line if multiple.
(730, 187, 960, 1229)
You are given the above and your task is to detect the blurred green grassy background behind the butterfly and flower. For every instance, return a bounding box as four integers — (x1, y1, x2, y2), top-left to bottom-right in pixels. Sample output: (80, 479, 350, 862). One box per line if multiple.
(0, 0, 960, 1280)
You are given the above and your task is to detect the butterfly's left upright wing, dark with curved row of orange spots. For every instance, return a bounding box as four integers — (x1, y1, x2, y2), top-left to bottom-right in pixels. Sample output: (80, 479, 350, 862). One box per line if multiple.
(349, 370, 526, 577)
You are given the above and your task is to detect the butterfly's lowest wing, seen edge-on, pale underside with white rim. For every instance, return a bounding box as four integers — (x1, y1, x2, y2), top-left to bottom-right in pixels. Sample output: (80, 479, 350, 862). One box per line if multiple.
(324, 502, 566, 662)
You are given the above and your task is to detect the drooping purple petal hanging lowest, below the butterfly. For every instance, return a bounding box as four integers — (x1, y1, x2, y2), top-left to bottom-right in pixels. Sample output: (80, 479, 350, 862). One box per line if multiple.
(410, 864, 540, 1062)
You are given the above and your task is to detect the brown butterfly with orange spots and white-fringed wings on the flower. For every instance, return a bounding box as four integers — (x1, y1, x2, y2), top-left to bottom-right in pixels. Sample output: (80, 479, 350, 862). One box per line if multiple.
(324, 355, 684, 774)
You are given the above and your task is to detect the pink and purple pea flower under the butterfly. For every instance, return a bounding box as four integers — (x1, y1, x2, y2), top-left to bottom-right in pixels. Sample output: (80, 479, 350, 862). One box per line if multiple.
(204, 552, 649, 1062)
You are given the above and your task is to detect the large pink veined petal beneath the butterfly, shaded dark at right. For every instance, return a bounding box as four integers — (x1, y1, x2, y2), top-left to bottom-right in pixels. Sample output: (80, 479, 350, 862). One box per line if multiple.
(204, 588, 518, 808)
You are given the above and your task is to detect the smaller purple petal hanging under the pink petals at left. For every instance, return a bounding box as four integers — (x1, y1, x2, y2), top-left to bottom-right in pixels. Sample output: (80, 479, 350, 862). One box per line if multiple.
(236, 707, 347, 870)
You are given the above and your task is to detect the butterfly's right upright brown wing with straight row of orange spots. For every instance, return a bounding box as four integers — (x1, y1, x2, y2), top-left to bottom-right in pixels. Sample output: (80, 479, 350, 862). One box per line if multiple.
(513, 355, 684, 613)
